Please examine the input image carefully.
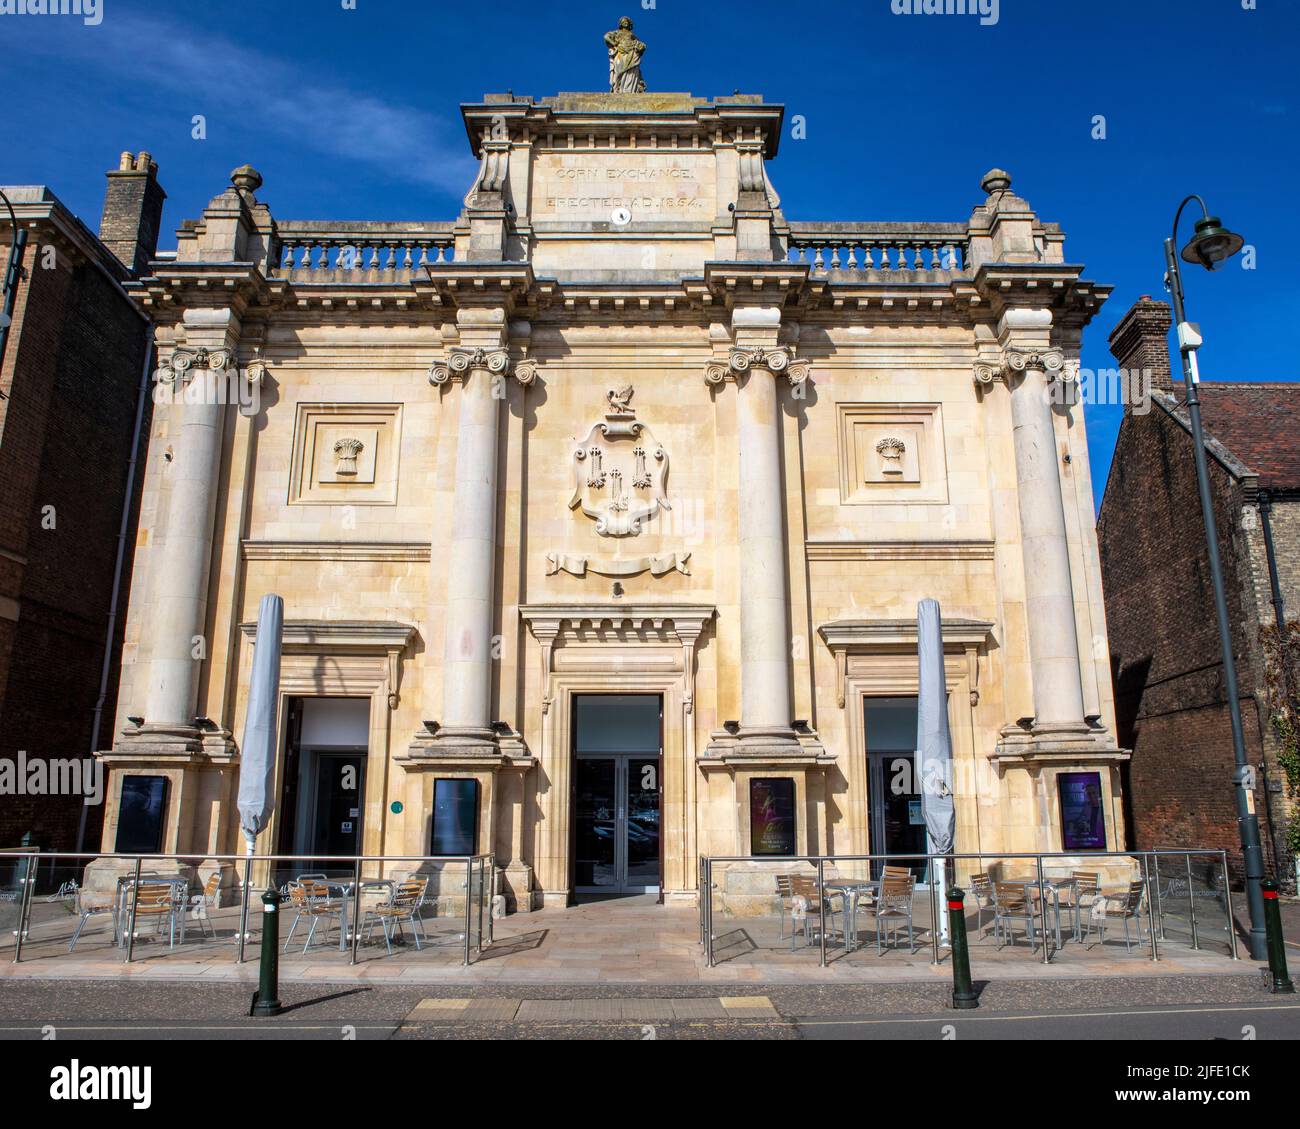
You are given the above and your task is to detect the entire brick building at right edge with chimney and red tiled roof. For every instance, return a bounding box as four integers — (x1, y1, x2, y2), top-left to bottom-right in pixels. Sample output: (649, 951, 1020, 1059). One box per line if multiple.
(1097, 298, 1300, 883)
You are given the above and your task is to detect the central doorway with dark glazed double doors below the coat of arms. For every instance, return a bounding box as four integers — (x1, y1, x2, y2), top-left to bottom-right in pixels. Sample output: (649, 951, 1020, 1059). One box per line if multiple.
(573, 695, 663, 895)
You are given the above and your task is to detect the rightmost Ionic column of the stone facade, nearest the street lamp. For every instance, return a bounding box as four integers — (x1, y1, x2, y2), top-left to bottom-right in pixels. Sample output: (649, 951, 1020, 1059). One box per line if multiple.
(976, 335, 1088, 732)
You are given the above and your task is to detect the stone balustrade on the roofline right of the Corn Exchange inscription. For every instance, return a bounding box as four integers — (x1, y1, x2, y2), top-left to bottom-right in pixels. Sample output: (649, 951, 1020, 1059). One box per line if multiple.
(789, 224, 969, 274)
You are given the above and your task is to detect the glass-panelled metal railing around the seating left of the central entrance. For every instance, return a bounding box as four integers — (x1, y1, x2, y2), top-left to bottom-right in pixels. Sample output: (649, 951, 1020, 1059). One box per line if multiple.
(0, 852, 493, 972)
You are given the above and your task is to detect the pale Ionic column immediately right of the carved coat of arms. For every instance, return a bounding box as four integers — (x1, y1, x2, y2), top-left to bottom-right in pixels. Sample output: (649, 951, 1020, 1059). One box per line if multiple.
(707, 347, 807, 752)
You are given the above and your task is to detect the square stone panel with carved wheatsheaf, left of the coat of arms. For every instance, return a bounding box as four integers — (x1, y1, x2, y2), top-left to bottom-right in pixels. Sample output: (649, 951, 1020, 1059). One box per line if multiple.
(289, 403, 402, 506)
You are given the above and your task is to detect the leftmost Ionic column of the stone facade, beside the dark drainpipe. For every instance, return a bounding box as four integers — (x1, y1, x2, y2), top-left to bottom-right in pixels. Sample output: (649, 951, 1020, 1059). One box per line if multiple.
(139, 311, 235, 741)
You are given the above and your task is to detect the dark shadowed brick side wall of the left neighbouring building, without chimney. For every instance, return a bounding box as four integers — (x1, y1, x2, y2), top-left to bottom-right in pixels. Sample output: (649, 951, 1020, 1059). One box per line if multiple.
(0, 230, 148, 849)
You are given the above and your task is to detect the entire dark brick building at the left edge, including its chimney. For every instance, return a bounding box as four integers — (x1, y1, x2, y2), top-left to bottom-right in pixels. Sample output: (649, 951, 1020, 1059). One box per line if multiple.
(0, 153, 164, 851)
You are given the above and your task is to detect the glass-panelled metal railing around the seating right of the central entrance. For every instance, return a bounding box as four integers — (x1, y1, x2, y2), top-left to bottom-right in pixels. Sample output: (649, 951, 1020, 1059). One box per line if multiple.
(701, 851, 1235, 968)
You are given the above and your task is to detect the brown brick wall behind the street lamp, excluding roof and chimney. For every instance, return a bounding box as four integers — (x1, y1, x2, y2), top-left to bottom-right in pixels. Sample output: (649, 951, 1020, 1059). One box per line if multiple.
(1097, 406, 1283, 881)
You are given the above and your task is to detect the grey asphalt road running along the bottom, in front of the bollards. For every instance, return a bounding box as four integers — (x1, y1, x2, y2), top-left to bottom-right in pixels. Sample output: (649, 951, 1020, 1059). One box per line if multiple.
(0, 973, 1300, 1042)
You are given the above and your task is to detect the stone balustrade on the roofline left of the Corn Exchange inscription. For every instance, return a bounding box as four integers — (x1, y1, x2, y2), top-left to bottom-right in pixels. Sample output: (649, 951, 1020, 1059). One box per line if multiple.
(272, 222, 455, 281)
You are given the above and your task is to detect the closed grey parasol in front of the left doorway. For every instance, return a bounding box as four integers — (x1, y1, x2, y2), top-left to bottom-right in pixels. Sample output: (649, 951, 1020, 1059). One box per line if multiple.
(239, 596, 285, 935)
